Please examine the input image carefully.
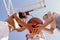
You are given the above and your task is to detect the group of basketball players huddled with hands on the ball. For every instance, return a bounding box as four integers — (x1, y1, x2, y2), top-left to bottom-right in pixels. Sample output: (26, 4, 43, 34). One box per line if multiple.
(0, 10, 60, 40)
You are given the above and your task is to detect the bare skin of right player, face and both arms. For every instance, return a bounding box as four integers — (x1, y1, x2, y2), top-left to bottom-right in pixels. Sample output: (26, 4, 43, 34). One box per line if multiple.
(38, 12, 56, 34)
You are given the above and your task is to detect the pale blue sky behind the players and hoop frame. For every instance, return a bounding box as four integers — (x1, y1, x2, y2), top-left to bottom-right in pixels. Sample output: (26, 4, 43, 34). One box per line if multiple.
(0, 0, 60, 40)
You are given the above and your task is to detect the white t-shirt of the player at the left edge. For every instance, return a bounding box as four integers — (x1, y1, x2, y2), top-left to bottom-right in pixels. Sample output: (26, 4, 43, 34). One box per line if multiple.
(0, 21, 9, 40)
